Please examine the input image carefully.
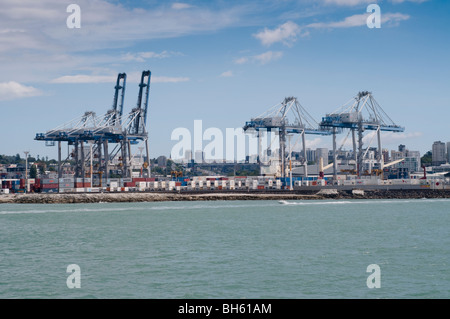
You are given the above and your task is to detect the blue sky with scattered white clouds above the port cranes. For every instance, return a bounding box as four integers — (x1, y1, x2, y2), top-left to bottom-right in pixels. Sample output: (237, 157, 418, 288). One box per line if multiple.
(0, 0, 450, 158)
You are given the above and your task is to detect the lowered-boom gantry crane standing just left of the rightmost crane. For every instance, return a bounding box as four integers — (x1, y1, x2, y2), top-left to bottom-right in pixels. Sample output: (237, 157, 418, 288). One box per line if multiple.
(243, 97, 331, 177)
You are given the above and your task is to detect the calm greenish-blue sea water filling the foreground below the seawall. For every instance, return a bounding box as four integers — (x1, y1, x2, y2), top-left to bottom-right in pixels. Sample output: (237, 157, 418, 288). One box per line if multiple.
(0, 199, 450, 299)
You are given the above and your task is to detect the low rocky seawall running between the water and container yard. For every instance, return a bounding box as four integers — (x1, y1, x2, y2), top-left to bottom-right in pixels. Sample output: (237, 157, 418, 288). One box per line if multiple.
(0, 189, 450, 204)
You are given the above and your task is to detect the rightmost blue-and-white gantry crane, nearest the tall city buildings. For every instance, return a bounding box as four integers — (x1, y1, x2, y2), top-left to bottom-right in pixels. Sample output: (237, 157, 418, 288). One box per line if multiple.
(320, 91, 405, 180)
